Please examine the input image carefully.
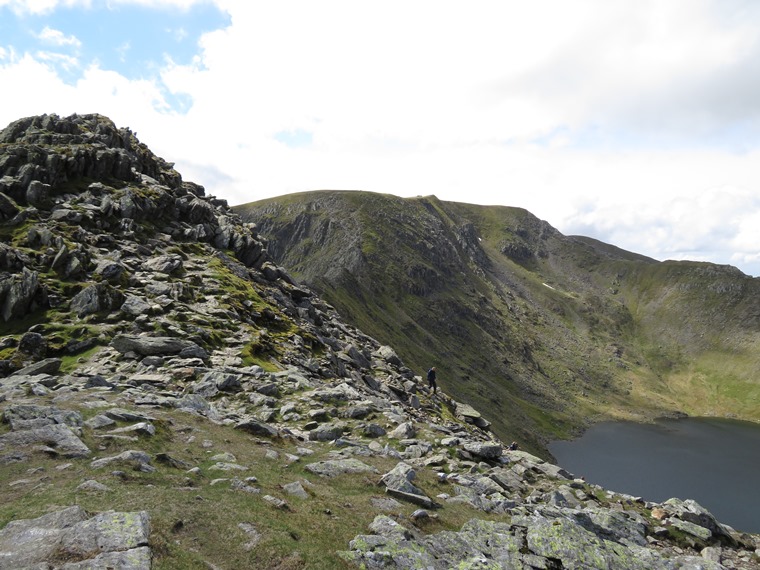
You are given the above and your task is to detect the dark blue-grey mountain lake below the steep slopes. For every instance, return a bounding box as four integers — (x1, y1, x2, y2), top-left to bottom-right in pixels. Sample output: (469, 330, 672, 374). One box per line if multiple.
(549, 412, 760, 532)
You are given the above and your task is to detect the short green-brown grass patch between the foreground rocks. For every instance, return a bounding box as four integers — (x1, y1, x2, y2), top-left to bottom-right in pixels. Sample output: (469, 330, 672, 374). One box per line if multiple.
(0, 402, 510, 570)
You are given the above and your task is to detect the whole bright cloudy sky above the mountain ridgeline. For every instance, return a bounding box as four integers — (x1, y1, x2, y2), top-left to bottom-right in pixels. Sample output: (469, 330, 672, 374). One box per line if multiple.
(0, 0, 760, 276)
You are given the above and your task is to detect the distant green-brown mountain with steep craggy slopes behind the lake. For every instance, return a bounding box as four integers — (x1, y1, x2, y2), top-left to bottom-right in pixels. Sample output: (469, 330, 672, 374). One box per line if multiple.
(235, 191, 760, 450)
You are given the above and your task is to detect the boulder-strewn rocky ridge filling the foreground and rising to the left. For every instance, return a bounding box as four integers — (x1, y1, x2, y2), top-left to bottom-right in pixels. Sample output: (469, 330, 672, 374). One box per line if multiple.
(0, 115, 760, 569)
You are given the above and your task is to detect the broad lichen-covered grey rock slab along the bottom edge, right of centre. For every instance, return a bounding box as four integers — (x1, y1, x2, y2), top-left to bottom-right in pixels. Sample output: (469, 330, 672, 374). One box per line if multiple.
(340, 515, 723, 570)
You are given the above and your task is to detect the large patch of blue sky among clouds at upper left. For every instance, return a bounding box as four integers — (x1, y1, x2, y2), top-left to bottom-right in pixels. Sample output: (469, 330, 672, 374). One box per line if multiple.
(0, 2, 230, 108)
